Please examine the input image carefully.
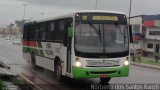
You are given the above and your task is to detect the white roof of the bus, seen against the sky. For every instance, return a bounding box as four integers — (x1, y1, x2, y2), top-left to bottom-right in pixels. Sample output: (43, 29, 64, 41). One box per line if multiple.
(26, 10, 124, 22)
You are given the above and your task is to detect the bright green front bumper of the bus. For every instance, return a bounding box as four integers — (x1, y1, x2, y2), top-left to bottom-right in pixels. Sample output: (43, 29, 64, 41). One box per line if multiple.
(72, 66, 129, 78)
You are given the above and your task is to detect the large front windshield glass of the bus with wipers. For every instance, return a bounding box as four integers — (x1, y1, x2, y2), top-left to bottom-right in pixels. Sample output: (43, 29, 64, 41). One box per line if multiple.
(75, 24, 128, 53)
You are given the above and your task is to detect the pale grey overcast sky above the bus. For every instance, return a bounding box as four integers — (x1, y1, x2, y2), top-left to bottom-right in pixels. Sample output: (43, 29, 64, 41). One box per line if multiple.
(0, 0, 160, 27)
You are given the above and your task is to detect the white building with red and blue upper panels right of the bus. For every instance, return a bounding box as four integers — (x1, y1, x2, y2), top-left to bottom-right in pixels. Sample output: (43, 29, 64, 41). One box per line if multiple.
(130, 15, 160, 54)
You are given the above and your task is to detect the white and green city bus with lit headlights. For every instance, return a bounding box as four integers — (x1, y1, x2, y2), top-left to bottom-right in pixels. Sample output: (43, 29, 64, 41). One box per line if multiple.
(23, 10, 132, 83)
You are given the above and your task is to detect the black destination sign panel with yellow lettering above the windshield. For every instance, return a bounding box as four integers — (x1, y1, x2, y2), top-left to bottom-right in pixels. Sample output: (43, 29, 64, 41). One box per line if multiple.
(75, 13, 127, 23)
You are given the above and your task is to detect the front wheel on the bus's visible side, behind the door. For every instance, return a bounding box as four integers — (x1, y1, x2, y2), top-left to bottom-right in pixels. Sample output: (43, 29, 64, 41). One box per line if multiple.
(55, 60, 63, 82)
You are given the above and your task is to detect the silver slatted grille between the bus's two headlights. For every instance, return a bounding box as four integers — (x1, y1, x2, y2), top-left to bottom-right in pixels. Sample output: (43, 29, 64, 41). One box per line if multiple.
(86, 60, 120, 67)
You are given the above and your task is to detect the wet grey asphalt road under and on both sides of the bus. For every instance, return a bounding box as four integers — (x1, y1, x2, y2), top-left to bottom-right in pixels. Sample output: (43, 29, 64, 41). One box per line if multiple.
(0, 40, 160, 90)
